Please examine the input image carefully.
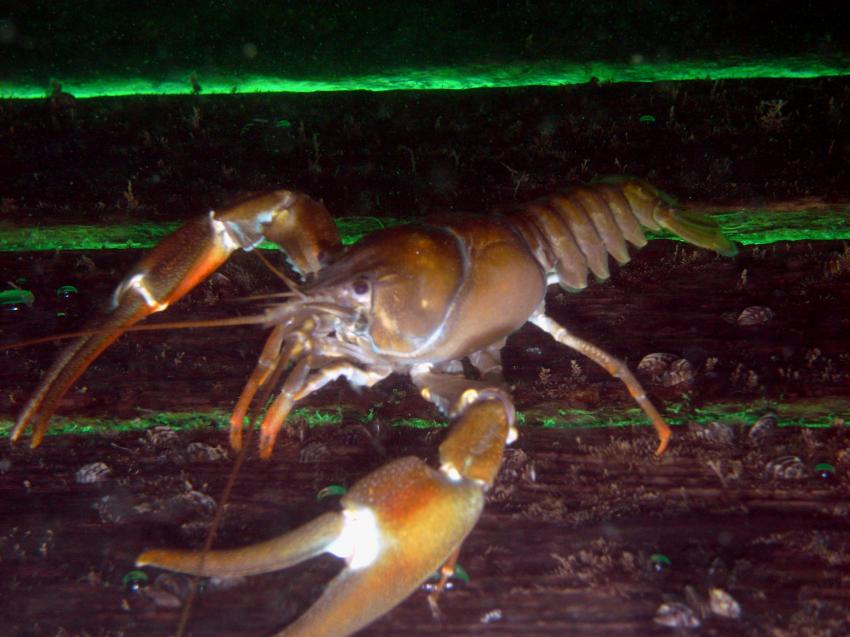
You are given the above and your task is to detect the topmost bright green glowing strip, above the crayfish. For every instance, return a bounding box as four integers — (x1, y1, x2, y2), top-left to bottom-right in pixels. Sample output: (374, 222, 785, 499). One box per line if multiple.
(0, 56, 850, 99)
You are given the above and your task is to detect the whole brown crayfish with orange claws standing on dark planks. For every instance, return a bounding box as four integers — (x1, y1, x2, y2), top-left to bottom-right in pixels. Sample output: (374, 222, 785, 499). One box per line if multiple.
(12, 178, 735, 635)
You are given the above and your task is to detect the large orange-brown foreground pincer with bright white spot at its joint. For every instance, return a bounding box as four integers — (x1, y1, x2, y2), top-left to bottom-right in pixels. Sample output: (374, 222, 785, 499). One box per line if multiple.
(136, 457, 484, 637)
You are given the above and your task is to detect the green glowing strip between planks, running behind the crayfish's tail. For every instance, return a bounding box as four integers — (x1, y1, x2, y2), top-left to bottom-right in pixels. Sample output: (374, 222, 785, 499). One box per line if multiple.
(0, 204, 850, 252)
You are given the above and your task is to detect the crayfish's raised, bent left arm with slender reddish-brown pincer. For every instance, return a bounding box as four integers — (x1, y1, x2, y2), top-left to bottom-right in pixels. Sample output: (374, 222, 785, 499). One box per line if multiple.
(12, 190, 339, 448)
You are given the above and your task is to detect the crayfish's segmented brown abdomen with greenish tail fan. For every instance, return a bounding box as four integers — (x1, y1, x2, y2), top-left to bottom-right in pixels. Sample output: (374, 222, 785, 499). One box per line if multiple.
(507, 177, 736, 290)
